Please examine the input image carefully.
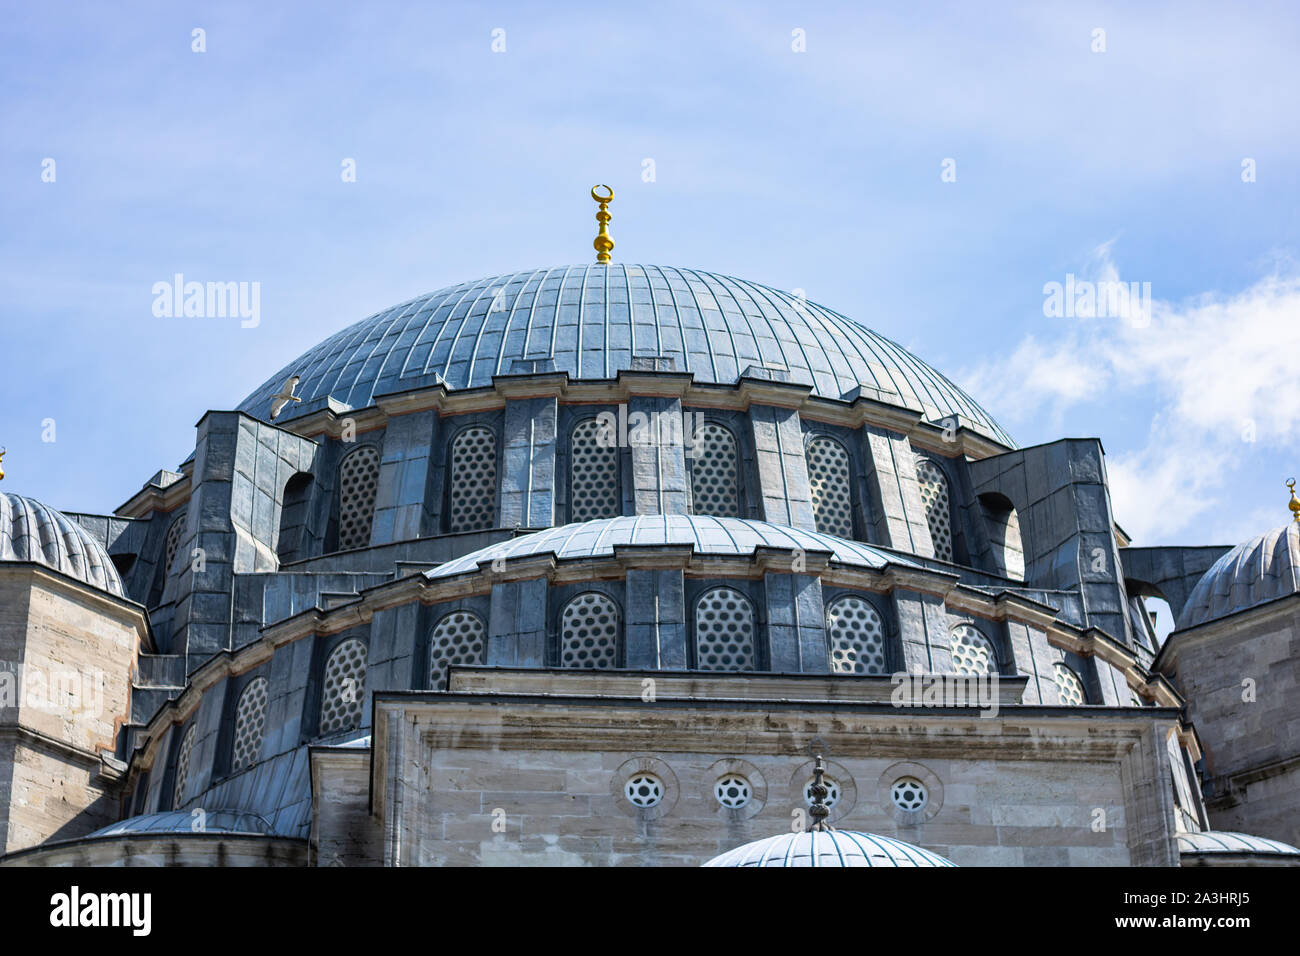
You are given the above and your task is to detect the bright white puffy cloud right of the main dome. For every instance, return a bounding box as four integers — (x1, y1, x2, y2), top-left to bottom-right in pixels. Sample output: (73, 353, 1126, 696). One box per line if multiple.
(966, 243, 1300, 542)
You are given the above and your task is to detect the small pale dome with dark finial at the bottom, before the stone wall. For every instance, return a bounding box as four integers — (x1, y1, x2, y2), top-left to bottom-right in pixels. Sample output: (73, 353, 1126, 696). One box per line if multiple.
(705, 830, 957, 866)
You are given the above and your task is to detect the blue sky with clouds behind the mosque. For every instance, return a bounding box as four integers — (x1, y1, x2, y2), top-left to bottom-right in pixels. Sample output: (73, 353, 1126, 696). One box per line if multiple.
(0, 3, 1300, 561)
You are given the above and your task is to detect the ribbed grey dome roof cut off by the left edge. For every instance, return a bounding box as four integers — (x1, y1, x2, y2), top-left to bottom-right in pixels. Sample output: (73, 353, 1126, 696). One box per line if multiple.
(0, 493, 125, 597)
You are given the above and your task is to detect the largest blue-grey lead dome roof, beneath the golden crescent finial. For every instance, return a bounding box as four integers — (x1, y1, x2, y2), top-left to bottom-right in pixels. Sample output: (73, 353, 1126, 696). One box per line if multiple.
(239, 264, 1014, 447)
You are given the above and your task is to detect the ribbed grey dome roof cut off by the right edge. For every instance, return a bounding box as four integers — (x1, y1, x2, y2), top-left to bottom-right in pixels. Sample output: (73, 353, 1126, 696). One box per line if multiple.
(1178, 522, 1300, 628)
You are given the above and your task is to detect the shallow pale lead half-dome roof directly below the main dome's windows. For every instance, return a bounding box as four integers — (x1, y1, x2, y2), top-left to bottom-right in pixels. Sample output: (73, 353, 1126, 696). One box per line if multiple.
(425, 515, 919, 579)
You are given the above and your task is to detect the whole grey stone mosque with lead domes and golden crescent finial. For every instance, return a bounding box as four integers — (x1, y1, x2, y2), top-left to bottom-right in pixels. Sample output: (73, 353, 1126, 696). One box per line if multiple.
(0, 187, 1300, 866)
